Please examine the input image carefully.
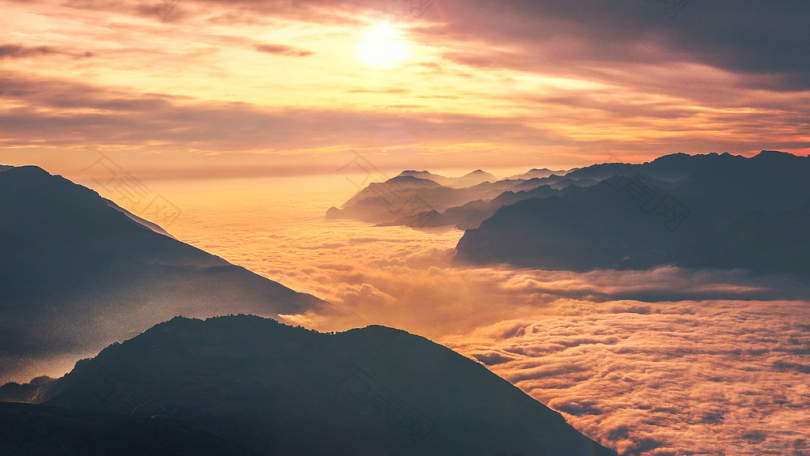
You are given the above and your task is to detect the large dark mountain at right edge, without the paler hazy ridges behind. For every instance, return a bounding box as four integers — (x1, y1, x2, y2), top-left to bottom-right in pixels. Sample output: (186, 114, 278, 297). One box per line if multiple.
(456, 151, 810, 275)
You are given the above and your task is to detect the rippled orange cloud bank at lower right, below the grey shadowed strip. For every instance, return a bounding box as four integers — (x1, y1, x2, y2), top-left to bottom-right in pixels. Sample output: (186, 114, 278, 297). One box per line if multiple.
(444, 301, 810, 455)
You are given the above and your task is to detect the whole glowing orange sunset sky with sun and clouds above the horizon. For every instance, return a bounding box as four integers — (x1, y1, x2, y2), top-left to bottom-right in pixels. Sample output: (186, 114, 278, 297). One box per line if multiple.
(0, 0, 810, 178)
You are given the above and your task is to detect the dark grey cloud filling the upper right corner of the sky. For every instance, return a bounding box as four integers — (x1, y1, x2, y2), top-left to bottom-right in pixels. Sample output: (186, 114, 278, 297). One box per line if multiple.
(422, 0, 810, 90)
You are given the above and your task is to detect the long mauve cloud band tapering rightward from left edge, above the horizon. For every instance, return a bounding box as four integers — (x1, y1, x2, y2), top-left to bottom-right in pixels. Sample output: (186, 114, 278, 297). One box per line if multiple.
(0, 73, 568, 152)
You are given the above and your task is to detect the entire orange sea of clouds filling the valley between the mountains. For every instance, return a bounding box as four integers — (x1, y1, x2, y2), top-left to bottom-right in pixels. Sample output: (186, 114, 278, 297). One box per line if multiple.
(94, 176, 810, 455)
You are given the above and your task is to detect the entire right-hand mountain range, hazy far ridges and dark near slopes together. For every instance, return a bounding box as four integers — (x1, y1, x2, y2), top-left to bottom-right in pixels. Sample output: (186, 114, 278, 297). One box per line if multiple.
(327, 151, 810, 276)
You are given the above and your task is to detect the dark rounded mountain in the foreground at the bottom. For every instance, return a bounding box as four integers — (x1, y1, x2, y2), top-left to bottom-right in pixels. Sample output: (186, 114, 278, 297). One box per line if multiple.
(0, 315, 615, 456)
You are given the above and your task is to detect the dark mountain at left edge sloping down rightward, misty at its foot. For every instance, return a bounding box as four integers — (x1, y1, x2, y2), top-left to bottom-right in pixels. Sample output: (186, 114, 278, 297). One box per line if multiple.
(0, 166, 357, 381)
